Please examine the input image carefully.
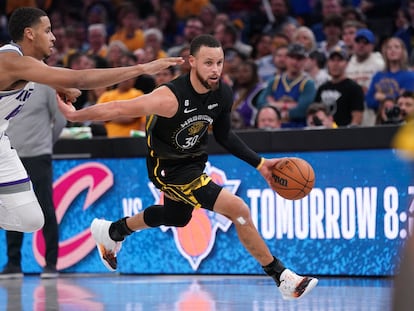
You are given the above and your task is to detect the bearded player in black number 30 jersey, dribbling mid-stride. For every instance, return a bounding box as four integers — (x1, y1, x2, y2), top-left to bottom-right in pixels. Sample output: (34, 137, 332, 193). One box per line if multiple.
(59, 35, 318, 299)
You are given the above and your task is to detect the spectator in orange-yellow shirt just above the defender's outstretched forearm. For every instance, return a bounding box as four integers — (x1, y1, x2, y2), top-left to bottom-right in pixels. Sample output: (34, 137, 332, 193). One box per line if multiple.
(109, 3, 145, 52)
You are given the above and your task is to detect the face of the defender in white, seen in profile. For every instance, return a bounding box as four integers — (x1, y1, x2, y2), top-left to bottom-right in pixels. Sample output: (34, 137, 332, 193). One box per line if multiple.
(30, 16, 56, 59)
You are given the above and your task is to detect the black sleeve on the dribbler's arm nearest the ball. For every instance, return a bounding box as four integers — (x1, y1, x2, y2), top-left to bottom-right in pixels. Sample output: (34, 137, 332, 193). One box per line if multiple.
(213, 112, 262, 168)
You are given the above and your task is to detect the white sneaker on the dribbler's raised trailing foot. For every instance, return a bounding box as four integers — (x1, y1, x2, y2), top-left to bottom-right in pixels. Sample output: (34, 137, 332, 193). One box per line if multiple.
(91, 218, 122, 271)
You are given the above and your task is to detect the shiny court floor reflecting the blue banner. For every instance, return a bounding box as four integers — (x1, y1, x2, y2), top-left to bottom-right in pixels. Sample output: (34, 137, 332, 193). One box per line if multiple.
(0, 274, 393, 311)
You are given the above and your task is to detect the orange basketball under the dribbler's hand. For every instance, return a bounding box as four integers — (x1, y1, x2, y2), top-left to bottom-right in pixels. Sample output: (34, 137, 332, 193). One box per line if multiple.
(271, 157, 315, 200)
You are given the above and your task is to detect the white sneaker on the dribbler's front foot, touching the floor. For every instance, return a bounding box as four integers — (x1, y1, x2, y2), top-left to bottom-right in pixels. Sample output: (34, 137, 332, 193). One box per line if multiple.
(279, 269, 318, 300)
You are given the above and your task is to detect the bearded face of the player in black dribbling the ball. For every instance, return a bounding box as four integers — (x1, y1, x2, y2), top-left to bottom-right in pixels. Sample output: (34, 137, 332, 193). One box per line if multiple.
(190, 46, 224, 90)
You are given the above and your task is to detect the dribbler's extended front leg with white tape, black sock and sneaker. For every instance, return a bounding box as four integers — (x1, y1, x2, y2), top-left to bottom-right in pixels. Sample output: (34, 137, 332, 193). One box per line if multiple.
(213, 189, 318, 299)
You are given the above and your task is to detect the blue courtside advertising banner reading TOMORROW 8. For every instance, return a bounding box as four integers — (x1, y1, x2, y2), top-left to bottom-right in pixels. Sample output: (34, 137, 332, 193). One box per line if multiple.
(0, 149, 414, 276)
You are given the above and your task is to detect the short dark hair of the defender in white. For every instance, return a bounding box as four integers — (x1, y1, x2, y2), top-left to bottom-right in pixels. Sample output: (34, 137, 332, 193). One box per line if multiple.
(9, 7, 47, 42)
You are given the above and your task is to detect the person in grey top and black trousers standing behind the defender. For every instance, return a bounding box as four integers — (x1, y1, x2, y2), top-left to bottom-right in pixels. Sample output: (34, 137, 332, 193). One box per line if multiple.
(0, 84, 66, 279)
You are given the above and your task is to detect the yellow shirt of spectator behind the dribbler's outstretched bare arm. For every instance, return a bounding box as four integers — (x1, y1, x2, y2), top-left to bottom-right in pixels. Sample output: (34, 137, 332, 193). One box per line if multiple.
(96, 88, 145, 137)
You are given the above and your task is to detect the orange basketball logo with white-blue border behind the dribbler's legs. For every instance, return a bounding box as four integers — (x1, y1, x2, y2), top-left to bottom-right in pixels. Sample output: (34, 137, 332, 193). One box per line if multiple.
(148, 162, 240, 271)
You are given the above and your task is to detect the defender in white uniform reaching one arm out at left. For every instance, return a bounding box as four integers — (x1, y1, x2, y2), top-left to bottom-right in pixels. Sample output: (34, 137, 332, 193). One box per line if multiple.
(0, 8, 182, 232)
